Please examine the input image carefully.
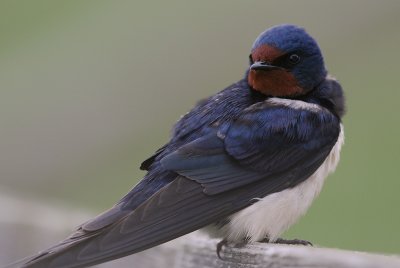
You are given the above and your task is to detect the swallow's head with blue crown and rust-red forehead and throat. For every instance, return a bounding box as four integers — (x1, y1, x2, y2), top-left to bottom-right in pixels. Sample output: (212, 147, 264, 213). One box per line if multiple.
(247, 24, 327, 97)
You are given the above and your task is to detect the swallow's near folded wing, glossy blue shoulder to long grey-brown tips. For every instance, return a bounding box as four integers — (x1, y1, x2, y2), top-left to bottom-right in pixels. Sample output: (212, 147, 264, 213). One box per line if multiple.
(24, 101, 339, 267)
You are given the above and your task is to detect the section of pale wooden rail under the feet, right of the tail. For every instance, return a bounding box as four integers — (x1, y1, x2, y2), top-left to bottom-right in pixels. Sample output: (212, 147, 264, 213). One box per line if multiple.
(115, 232, 400, 268)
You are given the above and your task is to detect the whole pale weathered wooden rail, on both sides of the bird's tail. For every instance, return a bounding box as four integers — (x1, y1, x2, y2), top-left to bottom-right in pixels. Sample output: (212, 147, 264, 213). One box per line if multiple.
(0, 189, 400, 268)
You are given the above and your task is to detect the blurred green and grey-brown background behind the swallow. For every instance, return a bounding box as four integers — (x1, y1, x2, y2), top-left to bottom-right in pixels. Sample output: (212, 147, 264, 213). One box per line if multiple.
(0, 0, 400, 258)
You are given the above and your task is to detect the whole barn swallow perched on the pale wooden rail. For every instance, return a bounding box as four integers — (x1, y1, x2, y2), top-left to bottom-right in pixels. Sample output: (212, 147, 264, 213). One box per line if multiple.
(12, 24, 344, 268)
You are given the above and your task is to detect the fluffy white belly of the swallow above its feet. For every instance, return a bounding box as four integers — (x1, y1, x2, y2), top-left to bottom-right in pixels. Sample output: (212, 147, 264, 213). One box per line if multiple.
(206, 125, 344, 242)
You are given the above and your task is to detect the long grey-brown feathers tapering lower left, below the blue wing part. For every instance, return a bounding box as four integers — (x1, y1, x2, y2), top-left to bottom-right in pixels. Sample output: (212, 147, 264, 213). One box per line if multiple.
(14, 178, 248, 268)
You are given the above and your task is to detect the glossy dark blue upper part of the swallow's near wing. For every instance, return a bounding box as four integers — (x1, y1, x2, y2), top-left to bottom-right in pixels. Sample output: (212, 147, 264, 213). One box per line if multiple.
(161, 101, 340, 195)
